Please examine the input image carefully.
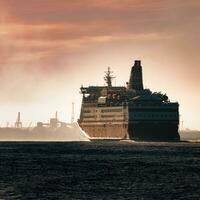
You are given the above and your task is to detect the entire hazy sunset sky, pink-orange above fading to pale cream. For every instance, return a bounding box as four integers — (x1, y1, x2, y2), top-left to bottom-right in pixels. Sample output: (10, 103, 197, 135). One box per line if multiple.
(0, 0, 200, 129)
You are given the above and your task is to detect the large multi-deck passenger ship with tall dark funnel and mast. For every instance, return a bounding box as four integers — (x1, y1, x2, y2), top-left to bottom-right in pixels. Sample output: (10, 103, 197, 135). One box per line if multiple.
(78, 60, 180, 141)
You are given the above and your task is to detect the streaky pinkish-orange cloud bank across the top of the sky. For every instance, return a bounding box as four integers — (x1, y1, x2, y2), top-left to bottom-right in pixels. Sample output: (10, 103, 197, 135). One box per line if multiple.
(0, 0, 200, 68)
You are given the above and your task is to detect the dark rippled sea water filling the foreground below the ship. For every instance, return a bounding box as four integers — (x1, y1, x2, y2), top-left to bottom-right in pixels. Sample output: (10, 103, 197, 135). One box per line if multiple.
(0, 142, 200, 199)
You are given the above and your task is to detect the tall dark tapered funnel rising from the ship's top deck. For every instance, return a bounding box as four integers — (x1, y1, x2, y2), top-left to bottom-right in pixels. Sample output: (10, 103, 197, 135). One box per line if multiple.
(128, 60, 143, 90)
